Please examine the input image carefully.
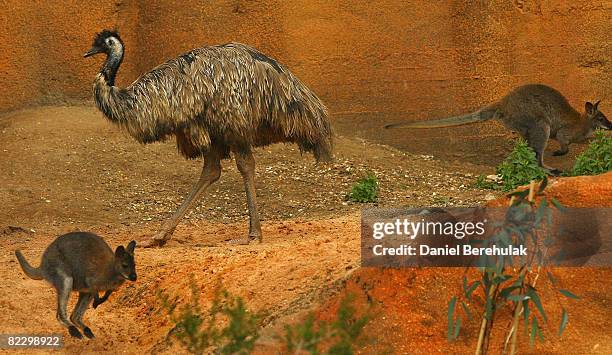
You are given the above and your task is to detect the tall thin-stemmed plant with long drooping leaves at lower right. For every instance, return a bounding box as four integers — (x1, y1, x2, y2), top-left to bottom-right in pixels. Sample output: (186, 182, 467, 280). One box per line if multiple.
(447, 178, 578, 354)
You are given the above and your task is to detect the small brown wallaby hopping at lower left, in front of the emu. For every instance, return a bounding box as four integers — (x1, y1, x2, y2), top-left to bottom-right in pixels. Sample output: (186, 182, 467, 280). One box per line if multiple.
(15, 232, 136, 338)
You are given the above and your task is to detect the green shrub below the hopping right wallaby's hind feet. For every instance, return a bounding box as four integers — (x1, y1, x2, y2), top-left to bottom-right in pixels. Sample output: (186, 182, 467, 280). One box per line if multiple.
(497, 139, 546, 191)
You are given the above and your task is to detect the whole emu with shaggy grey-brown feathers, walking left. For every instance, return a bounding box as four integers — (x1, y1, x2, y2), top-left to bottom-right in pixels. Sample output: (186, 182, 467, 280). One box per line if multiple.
(84, 30, 333, 246)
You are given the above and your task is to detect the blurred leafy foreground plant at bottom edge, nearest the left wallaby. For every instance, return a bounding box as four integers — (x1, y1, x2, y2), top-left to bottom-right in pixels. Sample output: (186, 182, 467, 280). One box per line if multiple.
(158, 275, 260, 354)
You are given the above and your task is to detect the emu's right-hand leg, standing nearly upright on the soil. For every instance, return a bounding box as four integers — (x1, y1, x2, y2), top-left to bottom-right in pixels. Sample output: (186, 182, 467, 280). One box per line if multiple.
(234, 152, 262, 244)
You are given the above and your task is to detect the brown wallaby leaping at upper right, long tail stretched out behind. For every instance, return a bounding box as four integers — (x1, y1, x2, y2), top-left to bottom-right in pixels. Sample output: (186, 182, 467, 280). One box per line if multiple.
(385, 84, 612, 175)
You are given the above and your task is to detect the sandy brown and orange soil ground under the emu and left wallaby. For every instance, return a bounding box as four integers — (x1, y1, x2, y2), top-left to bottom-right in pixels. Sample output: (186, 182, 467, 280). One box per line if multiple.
(0, 107, 611, 353)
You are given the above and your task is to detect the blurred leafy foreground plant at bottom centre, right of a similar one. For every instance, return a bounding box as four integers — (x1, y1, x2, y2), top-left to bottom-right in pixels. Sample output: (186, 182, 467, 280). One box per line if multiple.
(283, 296, 370, 355)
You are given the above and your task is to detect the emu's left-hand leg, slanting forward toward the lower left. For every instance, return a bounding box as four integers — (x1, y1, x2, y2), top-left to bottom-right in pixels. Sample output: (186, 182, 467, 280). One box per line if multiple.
(141, 153, 221, 247)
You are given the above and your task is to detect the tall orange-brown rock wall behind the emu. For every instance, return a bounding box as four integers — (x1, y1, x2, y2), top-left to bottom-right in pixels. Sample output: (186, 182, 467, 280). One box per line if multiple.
(0, 0, 612, 163)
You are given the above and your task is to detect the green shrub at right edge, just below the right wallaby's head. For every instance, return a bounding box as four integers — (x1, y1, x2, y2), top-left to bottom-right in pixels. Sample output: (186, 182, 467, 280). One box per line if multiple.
(572, 130, 612, 176)
